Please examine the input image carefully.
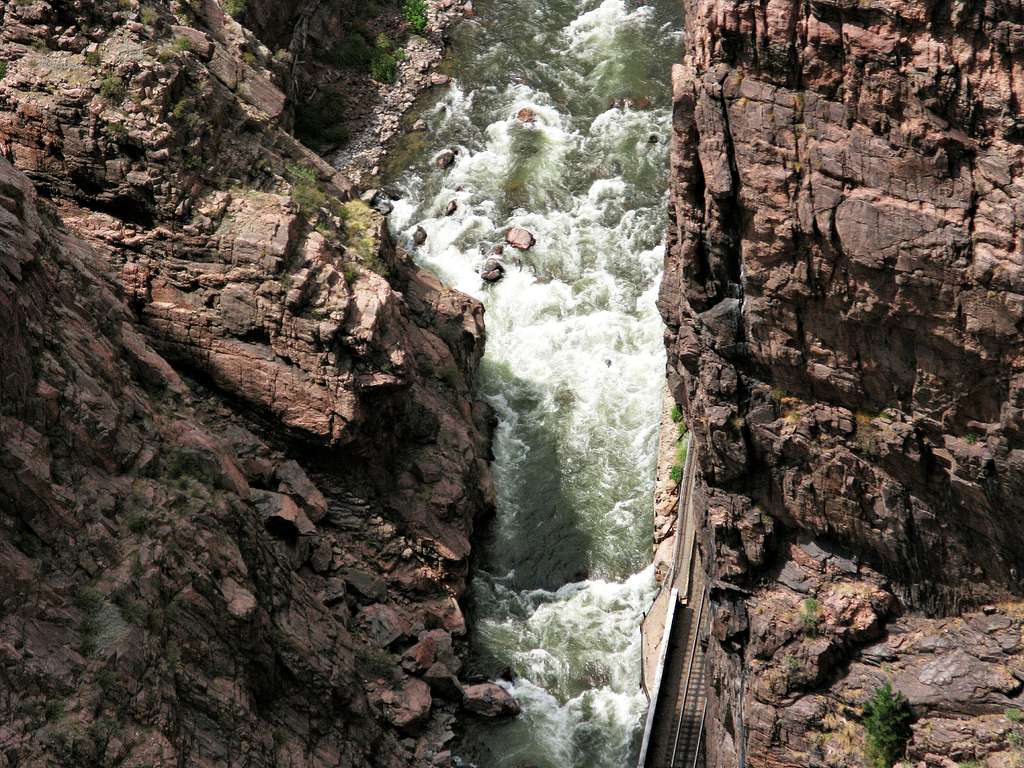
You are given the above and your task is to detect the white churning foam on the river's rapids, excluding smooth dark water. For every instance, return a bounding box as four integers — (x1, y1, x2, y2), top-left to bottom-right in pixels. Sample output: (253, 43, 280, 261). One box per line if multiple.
(391, 0, 676, 768)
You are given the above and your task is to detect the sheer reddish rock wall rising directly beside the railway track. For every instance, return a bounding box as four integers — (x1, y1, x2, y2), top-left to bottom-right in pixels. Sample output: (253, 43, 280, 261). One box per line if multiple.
(660, 0, 1024, 766)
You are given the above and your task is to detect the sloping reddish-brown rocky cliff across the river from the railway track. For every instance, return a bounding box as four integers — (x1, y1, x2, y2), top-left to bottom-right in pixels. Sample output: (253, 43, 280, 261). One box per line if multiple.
(0, 0, 494, 766)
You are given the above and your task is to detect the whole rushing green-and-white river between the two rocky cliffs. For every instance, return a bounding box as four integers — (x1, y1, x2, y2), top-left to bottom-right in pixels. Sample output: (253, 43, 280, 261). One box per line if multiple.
(387, 0, 681, 768)
